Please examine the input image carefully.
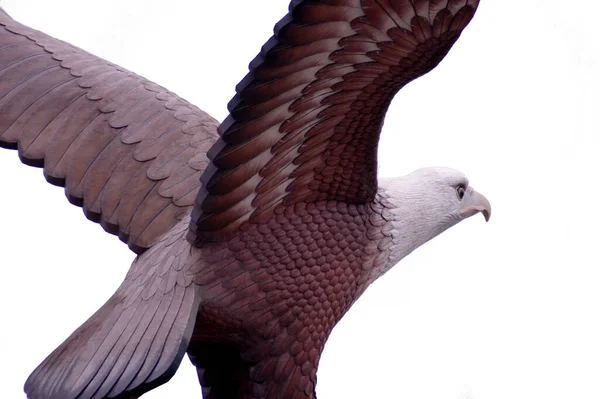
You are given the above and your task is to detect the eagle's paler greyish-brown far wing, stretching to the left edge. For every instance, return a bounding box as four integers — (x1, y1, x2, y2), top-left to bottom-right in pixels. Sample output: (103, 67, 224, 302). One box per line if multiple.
(0, 9, 218, 253)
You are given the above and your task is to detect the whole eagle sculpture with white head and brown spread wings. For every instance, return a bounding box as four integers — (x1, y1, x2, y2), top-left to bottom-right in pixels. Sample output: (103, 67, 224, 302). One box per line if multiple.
(0, 0, 491, 399)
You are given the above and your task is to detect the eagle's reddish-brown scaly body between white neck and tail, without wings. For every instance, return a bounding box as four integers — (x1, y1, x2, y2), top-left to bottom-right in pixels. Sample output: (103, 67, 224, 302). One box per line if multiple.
(189, 197, 392, 398)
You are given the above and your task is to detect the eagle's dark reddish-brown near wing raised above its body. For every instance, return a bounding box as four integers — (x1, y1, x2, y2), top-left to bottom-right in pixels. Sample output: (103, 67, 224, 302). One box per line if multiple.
(188, 0, 479, 243)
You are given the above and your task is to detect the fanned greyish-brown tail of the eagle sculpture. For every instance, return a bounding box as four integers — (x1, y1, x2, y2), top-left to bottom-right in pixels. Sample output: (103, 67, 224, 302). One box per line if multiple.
(25, 236, 199, 399)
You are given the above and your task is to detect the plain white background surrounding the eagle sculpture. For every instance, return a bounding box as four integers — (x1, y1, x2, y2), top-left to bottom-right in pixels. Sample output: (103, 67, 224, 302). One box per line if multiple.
(0, 0, 600, 399)
